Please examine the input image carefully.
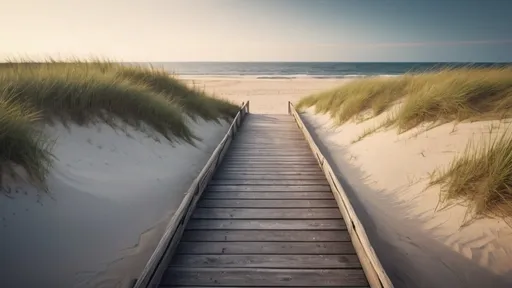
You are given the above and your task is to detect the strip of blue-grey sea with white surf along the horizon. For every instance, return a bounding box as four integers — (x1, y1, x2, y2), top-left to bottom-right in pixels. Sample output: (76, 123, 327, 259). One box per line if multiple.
(138, 62, 512, 79)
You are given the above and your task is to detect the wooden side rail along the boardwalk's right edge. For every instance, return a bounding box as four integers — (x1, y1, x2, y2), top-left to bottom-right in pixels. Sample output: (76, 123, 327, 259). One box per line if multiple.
(288, 102, 393, 288)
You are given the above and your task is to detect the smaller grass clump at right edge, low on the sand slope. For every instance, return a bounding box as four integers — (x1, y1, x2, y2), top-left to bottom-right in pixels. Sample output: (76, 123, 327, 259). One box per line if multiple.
(430, 132, 512, 220)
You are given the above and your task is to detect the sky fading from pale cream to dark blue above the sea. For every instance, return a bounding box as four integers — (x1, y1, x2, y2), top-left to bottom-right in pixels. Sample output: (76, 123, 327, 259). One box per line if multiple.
(0, 0, 512, 62)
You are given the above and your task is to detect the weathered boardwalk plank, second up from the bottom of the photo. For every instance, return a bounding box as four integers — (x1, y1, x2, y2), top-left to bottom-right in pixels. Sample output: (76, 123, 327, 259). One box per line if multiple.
(171, 255, 361, 269)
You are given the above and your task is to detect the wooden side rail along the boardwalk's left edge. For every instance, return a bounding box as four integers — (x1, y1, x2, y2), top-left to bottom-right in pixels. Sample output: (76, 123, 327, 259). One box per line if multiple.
(133, 102, 249, 288)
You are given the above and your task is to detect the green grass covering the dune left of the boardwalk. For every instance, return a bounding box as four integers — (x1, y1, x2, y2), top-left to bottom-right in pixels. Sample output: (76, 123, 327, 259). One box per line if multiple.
(0, 59, 239, 188)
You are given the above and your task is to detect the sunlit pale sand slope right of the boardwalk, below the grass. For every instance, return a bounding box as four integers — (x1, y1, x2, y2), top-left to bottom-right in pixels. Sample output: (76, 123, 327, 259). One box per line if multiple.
(304, 110, 512, 287)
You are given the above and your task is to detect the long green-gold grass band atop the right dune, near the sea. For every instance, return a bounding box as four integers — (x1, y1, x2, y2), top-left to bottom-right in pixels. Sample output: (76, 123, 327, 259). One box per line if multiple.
(297, 67, 512, 131)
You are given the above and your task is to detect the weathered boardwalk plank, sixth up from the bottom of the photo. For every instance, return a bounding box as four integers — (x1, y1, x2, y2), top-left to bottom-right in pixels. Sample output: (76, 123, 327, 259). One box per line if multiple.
(192, 208, 341, 220)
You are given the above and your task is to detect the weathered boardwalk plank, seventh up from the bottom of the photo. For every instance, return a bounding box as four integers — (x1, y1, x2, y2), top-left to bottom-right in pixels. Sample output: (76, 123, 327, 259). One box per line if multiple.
(197, 199, 338, 208)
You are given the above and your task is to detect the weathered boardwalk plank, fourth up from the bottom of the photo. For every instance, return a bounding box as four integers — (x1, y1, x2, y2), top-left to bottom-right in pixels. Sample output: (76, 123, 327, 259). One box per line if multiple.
(182, 230, 350, 243)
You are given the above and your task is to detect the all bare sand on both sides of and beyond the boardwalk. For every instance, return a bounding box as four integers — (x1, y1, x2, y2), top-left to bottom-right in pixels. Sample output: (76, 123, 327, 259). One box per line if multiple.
(0, 66, 512, 288)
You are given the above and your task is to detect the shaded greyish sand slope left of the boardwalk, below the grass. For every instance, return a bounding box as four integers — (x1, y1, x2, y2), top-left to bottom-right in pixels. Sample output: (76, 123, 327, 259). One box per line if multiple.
(0, 118, 227, 288)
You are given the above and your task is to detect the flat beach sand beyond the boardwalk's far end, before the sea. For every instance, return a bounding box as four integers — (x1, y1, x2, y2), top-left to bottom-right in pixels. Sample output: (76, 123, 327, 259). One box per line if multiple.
(180, 76, 347, 114)
